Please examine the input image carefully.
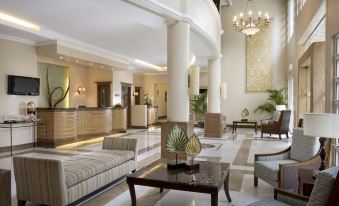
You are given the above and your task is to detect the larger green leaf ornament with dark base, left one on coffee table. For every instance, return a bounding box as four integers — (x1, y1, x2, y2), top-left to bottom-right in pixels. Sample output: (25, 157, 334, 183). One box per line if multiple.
(166, 125, 188, 170)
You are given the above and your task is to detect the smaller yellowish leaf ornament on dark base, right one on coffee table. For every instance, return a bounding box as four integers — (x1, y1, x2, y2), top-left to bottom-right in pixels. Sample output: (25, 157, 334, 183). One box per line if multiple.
(185, 134, 202, 170)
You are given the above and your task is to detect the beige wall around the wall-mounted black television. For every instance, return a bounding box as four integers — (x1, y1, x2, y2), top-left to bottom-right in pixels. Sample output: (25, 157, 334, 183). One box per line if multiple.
(0, 39, 38, 147)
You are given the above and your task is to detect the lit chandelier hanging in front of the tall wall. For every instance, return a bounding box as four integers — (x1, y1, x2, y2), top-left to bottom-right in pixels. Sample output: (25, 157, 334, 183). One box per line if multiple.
(233, 0, 270, 37)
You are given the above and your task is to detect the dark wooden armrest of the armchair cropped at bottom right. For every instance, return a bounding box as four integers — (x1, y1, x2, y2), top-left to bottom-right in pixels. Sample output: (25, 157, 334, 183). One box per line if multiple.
(274, 188, 309, 206)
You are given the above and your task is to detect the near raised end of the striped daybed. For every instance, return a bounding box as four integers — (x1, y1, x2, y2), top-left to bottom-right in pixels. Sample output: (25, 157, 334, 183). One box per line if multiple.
(13, 156, 68, 205)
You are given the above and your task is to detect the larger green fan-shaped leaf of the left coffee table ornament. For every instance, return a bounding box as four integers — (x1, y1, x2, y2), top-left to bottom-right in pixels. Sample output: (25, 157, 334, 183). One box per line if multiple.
(166, 125, 188, 153)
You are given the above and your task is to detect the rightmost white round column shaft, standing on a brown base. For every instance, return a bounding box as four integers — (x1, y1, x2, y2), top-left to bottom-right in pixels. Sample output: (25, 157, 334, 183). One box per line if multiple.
(207, 58, 221, 113)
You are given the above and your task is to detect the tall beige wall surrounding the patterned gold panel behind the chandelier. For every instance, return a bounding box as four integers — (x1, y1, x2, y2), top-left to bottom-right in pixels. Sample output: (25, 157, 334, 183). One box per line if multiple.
(221, 0, 287, 124)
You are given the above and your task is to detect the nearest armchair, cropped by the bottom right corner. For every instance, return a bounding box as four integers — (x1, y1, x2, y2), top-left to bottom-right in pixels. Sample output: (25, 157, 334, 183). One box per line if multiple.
(248, 167, 339, 206)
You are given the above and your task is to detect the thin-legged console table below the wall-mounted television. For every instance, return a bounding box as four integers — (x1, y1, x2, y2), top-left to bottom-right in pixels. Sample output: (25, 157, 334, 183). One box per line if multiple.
(0, 119, 47, 156)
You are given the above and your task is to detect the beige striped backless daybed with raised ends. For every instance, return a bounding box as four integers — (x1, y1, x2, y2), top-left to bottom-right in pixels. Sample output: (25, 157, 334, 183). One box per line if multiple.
(13, 137, 137, 206)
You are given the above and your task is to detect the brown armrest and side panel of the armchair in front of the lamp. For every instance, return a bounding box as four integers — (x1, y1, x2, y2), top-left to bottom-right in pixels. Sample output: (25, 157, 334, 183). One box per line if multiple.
(279, 155, 321, 191)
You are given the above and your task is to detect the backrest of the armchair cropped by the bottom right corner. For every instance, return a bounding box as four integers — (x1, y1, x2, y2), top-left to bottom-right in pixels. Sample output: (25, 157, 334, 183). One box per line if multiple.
(308, 167, 339, 206)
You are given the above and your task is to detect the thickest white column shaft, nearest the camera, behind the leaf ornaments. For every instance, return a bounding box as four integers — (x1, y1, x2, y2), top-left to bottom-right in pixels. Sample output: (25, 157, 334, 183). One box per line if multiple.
(167, 21, 190, 122)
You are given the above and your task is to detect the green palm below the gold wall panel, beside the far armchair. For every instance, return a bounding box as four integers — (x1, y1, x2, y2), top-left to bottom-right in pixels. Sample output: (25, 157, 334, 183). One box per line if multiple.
(254, 88, 287, 114)
